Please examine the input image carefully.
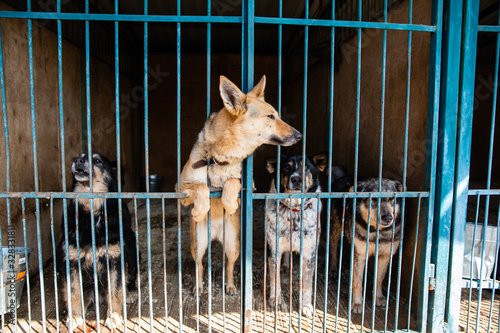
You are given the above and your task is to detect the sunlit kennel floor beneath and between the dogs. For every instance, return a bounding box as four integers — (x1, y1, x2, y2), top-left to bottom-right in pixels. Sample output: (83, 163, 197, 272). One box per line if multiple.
(2, 200, 499, 332)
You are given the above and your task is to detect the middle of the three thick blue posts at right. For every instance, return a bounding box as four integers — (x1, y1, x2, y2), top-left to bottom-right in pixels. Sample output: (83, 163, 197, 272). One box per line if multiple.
(429, 1, 463, 332)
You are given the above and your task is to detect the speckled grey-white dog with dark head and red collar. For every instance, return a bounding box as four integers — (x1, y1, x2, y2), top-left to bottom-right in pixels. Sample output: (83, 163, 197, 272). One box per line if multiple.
(266, 153, 327, 317)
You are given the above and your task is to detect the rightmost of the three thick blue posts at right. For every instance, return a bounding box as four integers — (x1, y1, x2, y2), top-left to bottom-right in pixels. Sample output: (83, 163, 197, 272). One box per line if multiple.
(446, 0, 480, 331)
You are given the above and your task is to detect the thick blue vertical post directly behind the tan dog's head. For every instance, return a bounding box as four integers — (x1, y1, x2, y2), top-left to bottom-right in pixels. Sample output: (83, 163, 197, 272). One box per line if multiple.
(241, 0, 255, 333)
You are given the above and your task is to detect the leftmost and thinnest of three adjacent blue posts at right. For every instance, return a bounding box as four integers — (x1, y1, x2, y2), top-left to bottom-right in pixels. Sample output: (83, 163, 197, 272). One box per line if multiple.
(417, 0, 443, 333)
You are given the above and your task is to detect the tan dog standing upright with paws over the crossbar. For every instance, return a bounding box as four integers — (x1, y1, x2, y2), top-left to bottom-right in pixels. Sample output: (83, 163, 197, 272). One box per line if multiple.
(180, 76, 302, 294)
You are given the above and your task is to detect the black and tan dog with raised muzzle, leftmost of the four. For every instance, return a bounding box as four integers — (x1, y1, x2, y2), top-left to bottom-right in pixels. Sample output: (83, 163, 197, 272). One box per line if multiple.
(57, 152, 137, 329)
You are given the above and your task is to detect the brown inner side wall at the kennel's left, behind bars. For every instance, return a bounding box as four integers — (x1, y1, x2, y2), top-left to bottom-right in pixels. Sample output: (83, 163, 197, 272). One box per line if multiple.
(0, 3, 134, 273)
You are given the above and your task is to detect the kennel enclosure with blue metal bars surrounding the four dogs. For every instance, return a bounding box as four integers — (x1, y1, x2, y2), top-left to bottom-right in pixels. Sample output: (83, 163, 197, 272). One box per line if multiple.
(0, 0, 500, 332)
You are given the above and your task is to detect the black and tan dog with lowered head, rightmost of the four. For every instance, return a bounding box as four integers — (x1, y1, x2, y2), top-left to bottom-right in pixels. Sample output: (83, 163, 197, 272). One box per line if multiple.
(330, 177, 404, 313)
